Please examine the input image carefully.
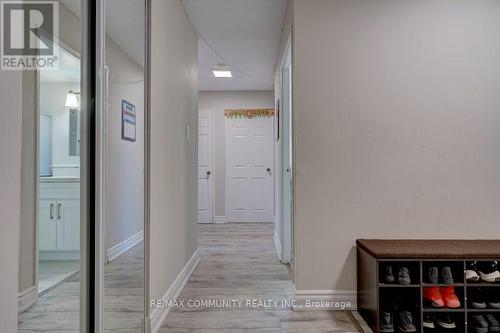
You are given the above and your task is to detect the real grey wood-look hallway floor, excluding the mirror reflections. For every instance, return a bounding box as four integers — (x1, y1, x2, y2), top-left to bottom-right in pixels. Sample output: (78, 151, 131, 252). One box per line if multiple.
(160, 223, 360, 333)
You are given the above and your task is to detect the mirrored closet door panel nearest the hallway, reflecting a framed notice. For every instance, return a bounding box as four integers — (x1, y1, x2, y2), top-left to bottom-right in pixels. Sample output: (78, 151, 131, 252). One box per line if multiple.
(102, 0, 146, 333)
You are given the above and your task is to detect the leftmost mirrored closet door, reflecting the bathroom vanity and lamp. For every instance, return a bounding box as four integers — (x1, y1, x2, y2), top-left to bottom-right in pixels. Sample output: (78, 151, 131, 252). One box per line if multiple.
(16, 0, 91, 332)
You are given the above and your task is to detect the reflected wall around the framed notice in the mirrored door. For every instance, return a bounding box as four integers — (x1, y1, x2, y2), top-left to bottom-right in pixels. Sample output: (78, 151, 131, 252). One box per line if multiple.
(106, 38, 144, 250)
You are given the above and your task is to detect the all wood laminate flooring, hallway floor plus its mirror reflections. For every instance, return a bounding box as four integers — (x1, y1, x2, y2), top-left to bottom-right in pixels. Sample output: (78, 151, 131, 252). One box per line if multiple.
(18, 223, 361, 333)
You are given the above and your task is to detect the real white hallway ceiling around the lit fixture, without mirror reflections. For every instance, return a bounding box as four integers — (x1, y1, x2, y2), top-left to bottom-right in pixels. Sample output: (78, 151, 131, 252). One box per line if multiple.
(182, 0, 287, 90)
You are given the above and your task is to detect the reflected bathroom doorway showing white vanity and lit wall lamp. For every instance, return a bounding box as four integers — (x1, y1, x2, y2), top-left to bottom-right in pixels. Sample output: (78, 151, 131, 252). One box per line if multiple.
(37, 45, 81, 297)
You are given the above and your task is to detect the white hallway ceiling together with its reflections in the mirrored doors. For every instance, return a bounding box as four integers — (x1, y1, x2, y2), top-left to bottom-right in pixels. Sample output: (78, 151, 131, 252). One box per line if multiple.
(61, 0, 288, 90)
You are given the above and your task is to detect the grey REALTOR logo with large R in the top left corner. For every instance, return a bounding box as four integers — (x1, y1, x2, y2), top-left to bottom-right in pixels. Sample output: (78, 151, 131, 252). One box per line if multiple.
(1, 1, 59, 70)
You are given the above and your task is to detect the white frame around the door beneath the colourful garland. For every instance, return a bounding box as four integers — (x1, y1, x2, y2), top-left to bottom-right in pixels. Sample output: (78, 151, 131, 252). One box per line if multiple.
(224, 117, 277, 223)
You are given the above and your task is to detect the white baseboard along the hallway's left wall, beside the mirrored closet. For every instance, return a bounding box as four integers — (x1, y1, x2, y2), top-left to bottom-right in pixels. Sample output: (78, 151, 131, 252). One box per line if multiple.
(150, 250, 200, 333)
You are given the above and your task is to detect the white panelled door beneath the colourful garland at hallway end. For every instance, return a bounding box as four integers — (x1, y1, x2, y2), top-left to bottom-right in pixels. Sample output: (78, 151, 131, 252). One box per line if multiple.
(226, 117, 274, 222)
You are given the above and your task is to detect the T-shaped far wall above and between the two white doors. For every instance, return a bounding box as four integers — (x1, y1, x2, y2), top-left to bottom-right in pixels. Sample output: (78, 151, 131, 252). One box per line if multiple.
(198, 91, 274, 216)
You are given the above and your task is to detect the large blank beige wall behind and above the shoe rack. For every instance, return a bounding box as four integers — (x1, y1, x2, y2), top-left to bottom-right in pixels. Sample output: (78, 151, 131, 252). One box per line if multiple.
(294, 0, 500, 290)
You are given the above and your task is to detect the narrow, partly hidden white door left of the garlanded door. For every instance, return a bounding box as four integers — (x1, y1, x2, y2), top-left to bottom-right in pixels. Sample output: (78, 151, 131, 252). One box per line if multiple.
(198, 110, 214, 223)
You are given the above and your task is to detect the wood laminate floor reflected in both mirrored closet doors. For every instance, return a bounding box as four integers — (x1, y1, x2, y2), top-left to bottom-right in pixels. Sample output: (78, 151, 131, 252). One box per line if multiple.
(18, 242, 144, 333)
